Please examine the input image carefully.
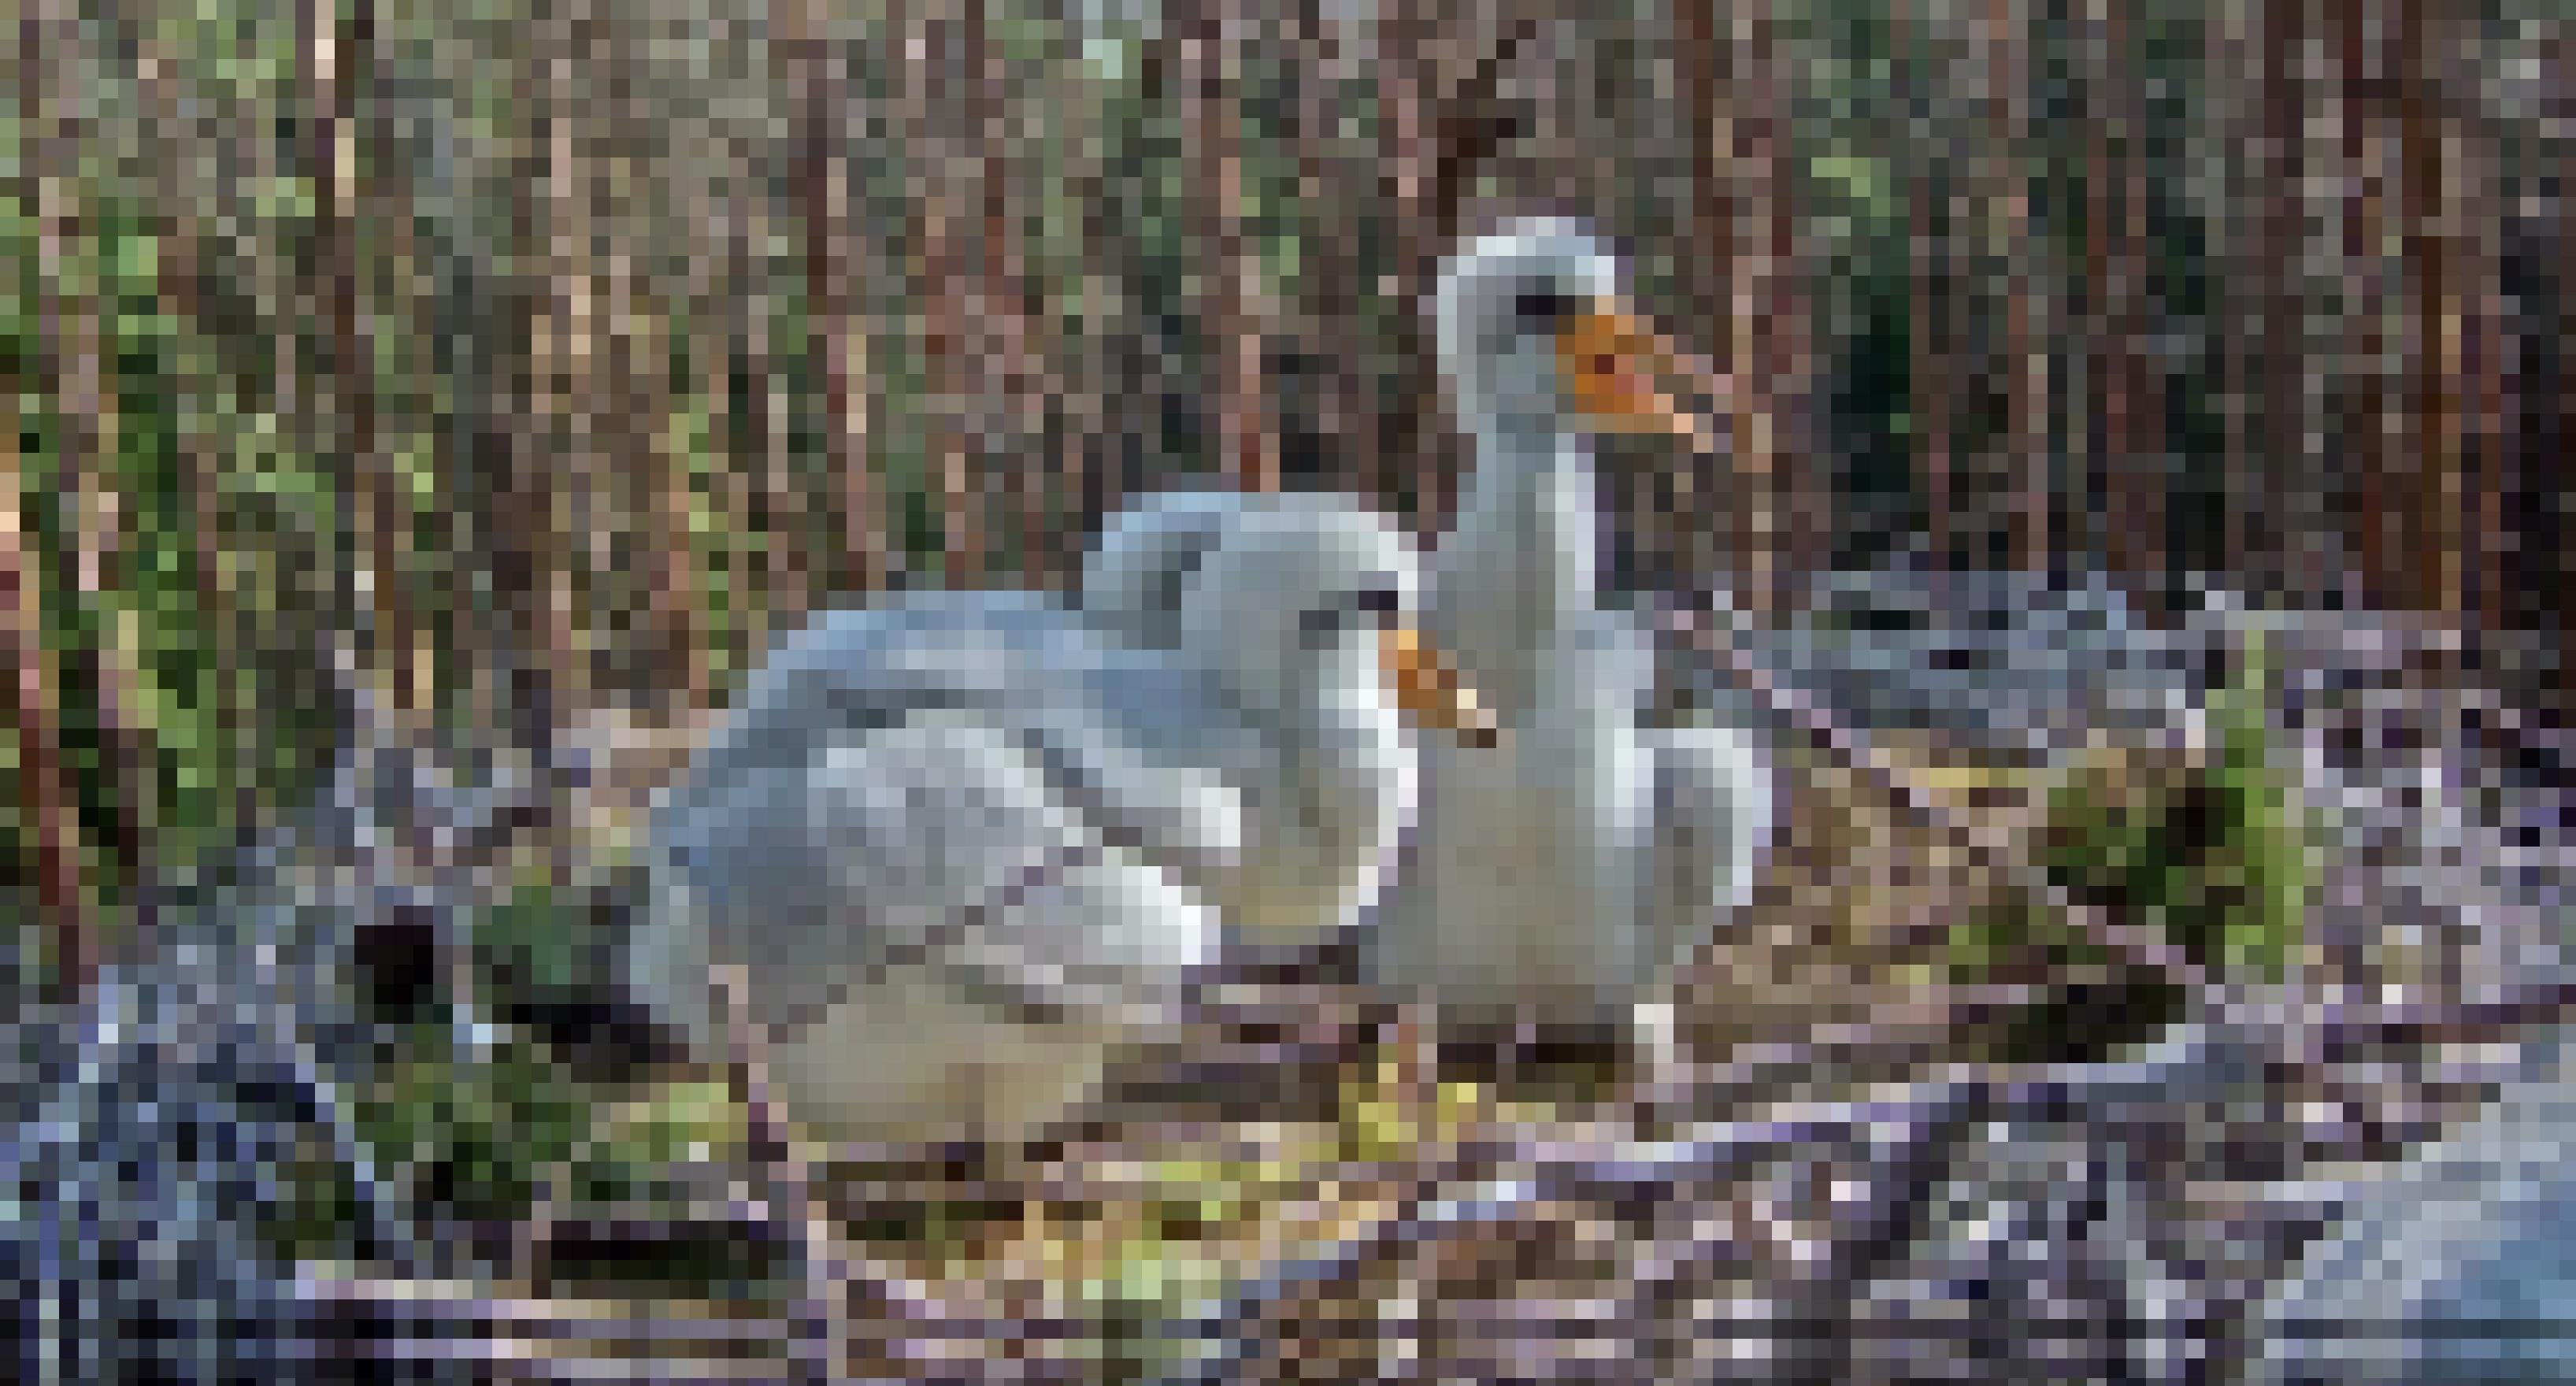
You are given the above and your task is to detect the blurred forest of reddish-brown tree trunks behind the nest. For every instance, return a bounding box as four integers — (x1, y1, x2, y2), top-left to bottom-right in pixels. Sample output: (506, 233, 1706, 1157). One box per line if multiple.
(0, 0, 2576, 984)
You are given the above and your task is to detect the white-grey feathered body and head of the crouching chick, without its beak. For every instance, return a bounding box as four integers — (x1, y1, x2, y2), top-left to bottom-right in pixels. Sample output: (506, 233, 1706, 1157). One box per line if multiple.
(631, 513, 1412, 1141)
